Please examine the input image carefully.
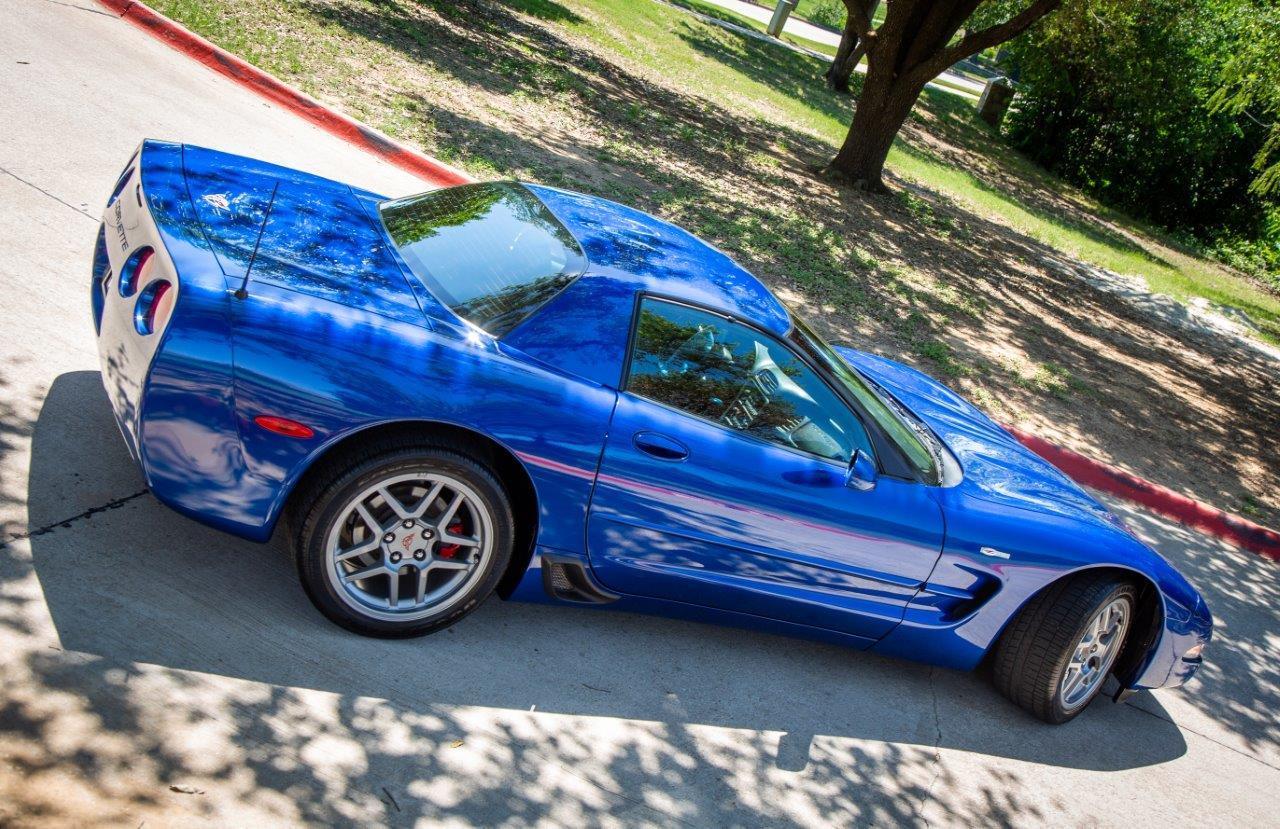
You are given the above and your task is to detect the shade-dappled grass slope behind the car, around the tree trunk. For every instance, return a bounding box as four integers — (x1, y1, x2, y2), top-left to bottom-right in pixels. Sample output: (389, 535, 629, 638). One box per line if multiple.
(151, 0, 1280, 523)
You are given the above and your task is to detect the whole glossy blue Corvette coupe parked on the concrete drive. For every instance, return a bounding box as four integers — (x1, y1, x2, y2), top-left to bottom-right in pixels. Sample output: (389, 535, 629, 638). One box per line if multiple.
(91, 141, 1212, 723)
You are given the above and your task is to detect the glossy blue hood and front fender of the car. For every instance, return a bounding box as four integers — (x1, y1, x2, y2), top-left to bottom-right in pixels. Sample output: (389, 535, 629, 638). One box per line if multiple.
(840, 348, 1211, 687)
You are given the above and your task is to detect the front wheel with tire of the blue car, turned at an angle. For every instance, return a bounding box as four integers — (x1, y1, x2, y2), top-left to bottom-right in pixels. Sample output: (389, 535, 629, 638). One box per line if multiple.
(992, 573, 1137, 724)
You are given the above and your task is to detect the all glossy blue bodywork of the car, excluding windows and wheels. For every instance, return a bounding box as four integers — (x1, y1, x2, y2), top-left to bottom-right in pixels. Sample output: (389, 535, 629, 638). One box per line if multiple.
(93, 142, 1211, 687)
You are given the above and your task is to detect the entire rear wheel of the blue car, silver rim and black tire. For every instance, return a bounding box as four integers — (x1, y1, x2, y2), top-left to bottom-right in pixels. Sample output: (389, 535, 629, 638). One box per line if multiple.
(296, 446, 513, 637)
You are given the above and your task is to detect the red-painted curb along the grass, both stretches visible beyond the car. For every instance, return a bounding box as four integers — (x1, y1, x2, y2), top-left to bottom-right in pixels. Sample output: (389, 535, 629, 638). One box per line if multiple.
(97, 0, 1280, 562)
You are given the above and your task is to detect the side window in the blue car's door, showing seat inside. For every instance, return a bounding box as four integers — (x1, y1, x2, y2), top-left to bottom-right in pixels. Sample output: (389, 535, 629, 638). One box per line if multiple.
(627, 299, 873, 462)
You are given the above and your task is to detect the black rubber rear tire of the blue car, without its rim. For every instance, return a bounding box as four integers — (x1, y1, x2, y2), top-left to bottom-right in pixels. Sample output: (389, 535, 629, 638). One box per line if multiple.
(287, 440, 515, 638)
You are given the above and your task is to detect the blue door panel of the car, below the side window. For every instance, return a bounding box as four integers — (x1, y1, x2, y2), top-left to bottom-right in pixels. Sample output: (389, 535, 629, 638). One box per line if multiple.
(588, 393, 942, 638)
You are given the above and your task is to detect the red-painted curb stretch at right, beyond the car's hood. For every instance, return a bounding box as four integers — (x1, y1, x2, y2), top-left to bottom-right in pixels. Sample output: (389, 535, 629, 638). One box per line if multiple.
(1005, 426, 1280, 562)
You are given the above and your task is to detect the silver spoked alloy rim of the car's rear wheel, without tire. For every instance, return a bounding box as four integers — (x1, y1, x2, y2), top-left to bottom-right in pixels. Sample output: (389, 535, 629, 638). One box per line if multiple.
(325, 472, 494, 622)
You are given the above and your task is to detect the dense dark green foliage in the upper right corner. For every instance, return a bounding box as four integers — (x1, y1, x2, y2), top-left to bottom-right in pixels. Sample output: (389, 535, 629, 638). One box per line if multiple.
(991, 0, 1280, 275)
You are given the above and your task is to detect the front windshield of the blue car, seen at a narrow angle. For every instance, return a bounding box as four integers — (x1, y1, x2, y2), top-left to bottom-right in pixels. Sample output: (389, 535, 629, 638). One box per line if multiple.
(788, 308, 942, 484)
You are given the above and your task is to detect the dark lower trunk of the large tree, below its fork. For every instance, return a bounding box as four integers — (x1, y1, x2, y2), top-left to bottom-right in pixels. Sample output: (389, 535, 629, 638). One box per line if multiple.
(828, 59, 924, 193)
